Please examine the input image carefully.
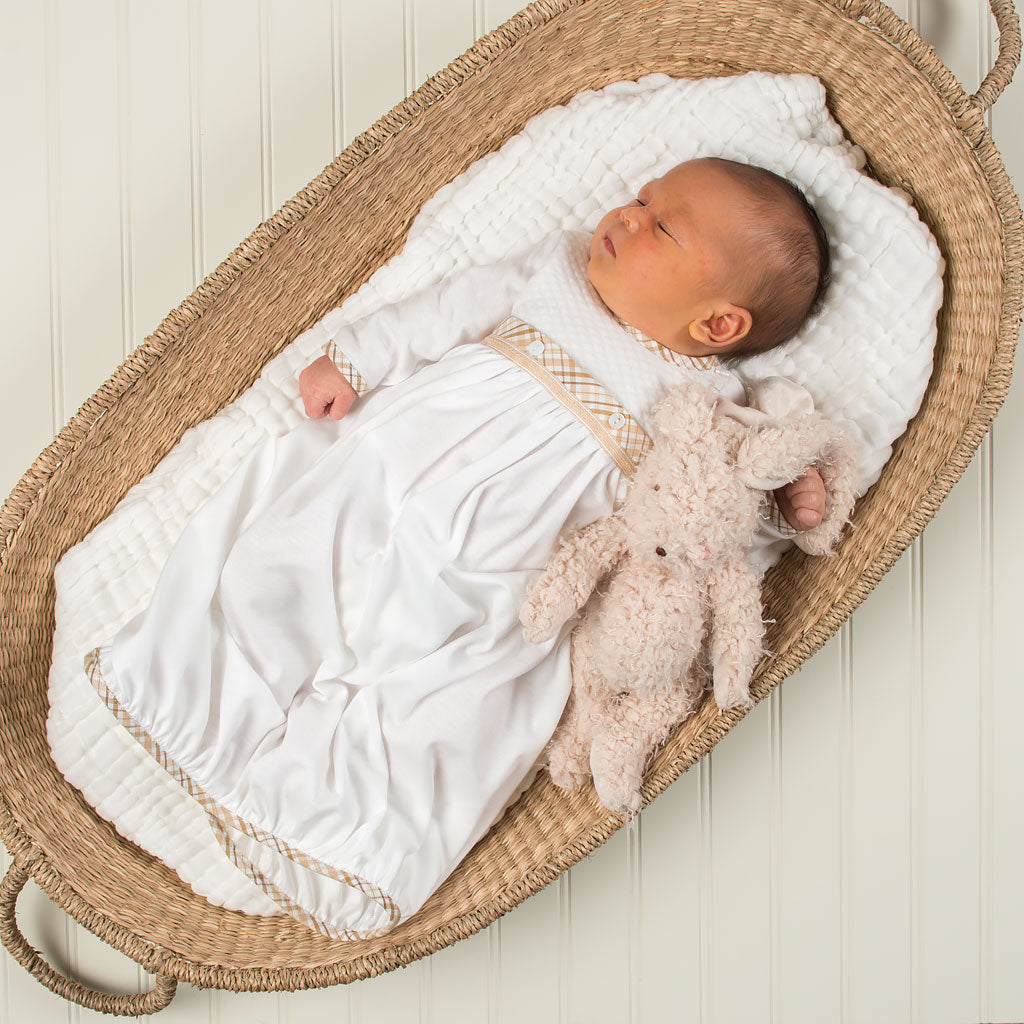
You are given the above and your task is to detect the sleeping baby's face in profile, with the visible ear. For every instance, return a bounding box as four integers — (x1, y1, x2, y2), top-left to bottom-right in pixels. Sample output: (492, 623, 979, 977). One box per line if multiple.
(587, 160, 750, 355)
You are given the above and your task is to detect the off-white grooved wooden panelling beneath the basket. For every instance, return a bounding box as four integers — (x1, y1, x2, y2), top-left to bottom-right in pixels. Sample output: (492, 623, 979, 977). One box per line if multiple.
(0, 0, 1024, 1024)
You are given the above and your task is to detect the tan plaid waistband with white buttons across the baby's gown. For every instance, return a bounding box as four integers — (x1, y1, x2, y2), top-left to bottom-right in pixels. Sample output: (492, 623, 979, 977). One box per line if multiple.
(483, 316, 651, 476)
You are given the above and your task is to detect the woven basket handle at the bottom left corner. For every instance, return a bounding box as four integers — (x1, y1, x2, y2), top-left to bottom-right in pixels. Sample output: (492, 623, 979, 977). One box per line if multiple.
(0, 858, 178, 1017)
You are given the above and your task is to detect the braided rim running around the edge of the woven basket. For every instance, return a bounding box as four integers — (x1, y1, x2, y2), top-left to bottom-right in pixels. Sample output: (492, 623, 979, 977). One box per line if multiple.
(0, 0, 1024, 990)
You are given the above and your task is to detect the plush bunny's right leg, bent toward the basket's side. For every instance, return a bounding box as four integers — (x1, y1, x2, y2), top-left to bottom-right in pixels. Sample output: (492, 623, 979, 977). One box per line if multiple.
(590, 669, 703, 814)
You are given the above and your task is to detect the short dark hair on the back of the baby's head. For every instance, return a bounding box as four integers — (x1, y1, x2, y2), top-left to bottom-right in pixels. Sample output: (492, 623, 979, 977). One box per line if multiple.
(715, 158, 831, 359)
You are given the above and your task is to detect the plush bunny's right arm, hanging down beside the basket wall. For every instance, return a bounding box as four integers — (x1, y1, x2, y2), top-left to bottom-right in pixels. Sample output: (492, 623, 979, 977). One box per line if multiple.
(708, 557, 765, 710)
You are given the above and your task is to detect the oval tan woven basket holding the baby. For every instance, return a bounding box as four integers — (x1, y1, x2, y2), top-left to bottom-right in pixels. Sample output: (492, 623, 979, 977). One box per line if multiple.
(0, 0, 1024, 1014)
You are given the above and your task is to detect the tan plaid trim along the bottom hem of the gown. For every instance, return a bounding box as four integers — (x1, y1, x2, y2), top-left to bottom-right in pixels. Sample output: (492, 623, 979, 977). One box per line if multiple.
(85, 647, 401, 939)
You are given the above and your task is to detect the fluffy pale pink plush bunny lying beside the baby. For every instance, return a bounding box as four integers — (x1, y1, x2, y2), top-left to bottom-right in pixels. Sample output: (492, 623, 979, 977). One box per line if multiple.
(520, 378, 855, 814)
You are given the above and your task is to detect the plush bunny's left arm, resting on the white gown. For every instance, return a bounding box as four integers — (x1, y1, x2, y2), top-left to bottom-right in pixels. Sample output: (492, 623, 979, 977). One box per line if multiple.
(519, 515, 627, 643)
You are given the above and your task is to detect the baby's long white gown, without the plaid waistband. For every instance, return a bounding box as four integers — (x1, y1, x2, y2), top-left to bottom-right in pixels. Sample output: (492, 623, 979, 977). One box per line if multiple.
(93, 232, 775, 936)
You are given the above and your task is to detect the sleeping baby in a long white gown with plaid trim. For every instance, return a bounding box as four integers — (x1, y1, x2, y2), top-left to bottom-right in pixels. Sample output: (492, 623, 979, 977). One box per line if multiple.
(87, 153, 828, 936)
